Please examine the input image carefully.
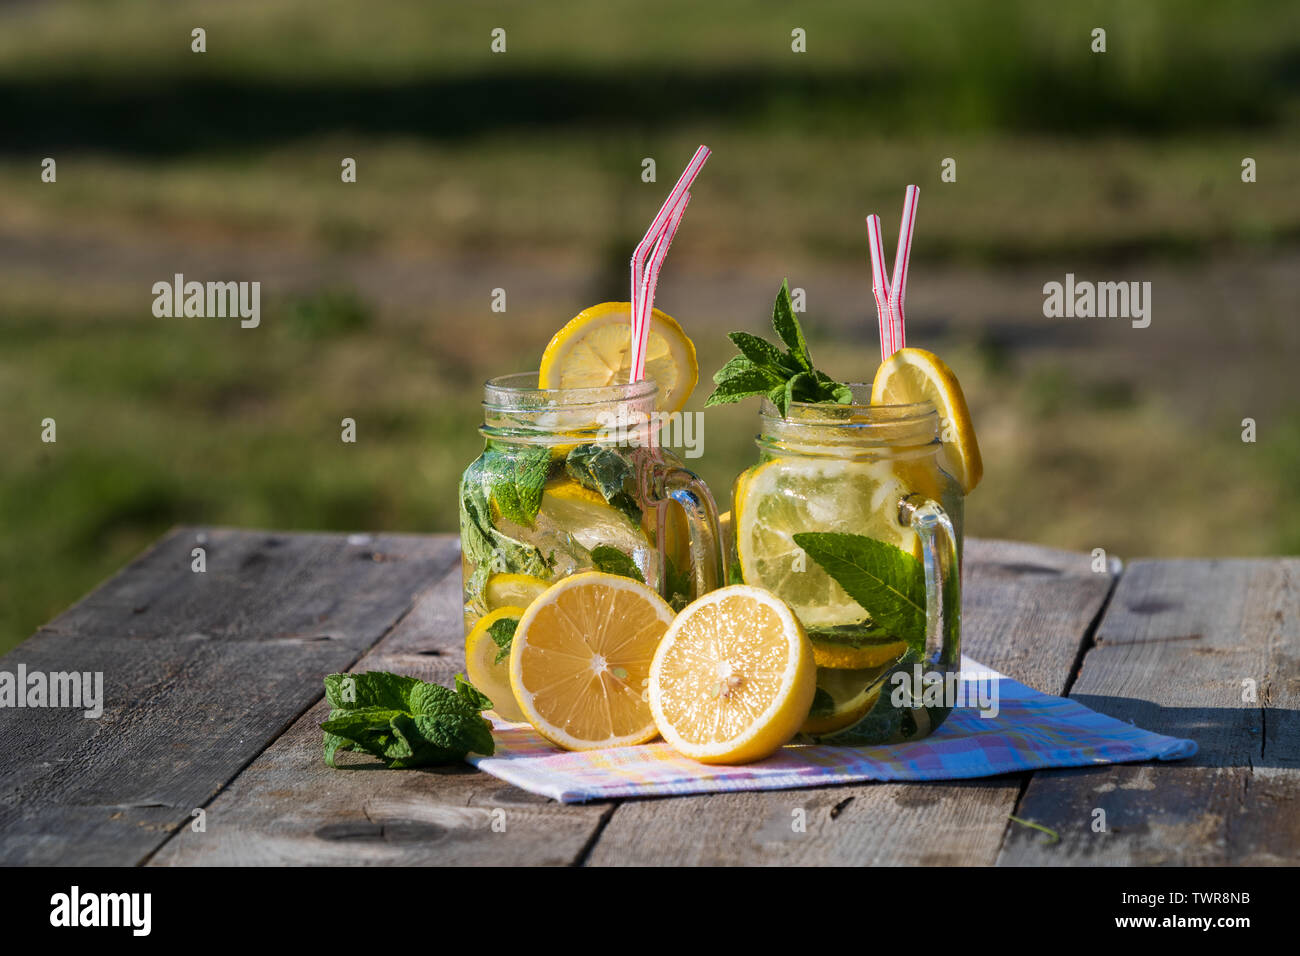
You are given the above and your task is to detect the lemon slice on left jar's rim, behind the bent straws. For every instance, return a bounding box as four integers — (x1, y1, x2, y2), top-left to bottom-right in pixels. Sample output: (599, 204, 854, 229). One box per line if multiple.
(537, 302, 699, 412)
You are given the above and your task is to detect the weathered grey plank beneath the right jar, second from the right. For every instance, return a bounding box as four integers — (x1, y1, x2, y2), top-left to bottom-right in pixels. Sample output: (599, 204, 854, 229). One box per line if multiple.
(589, 540, 1114, 865)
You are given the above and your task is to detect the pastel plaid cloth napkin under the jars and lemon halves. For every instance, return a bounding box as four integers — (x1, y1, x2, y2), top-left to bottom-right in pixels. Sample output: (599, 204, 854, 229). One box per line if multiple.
(468, 657, 1196, 804)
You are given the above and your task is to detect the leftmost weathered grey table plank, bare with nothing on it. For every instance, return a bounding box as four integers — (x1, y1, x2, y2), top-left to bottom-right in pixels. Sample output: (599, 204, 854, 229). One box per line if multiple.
(0, 529, 459, 865)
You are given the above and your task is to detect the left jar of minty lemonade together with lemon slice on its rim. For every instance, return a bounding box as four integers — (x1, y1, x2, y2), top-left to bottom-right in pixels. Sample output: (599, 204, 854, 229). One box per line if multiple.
(459, 303, 725, 721)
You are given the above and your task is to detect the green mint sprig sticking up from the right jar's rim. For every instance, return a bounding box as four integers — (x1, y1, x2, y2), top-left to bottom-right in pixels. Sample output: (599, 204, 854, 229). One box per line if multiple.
(705, 280, 853, 415)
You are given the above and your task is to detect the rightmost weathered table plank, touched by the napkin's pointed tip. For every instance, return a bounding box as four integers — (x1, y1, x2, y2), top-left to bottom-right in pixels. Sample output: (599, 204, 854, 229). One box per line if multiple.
(998, 558, 1300, 866)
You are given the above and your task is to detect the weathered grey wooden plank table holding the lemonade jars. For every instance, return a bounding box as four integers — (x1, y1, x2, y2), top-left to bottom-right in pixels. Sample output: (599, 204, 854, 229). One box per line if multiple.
(0, 528, 1300, 866)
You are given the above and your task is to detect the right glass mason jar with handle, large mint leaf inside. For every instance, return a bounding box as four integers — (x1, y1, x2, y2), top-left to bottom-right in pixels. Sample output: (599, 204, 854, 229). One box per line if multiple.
(732, 385, 963, 744)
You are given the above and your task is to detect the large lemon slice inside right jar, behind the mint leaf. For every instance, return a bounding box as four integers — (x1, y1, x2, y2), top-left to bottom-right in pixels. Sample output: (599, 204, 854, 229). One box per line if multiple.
(733, 458, 920, 627)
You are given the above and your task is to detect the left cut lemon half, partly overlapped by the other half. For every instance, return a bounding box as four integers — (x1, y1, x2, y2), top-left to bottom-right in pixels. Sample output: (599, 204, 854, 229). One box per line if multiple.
(510, 571, 672, 750)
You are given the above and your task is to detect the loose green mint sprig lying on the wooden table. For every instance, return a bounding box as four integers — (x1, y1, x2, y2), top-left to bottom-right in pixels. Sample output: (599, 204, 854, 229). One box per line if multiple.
(321, 671, 495, 769)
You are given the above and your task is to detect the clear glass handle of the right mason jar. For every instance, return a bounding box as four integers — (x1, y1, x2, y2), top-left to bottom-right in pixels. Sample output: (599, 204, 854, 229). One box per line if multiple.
(898, 494, 962, 672)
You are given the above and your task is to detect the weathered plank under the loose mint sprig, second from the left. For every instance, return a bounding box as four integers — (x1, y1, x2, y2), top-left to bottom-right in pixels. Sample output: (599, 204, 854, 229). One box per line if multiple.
(150, 546, 612, 865)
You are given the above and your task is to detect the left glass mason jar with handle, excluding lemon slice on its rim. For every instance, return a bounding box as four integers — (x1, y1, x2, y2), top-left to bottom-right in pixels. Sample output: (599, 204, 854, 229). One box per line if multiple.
(459, 372, 725, 635)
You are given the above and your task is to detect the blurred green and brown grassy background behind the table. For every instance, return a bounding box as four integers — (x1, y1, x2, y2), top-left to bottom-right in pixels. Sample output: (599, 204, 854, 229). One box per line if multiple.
(0, 0, 1300, 650)
